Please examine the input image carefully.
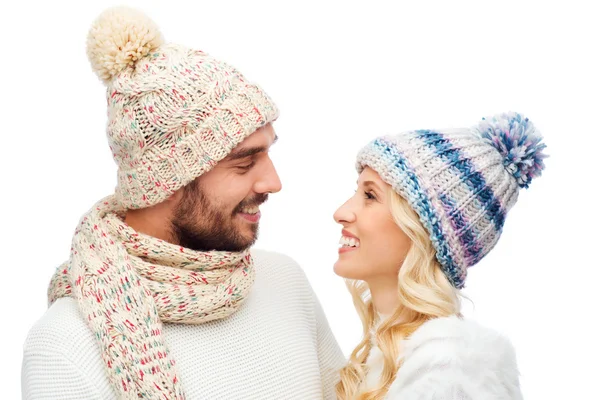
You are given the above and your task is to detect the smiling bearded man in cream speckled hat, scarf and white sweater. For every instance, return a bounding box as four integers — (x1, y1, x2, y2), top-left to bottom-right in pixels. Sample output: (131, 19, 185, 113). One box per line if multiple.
(22, 8, 344, 399)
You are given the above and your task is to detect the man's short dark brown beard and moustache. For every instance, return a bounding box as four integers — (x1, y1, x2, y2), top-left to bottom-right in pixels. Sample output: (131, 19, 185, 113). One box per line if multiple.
(171, 181, 268, 252)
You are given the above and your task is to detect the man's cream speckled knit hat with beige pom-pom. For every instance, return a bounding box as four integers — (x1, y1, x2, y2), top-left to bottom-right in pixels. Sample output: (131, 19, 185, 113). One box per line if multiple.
(87, 7, 278, 209)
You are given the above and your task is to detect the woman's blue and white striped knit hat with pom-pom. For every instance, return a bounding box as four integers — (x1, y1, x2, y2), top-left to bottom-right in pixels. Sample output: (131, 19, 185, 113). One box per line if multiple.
(357, 112, 546, 288)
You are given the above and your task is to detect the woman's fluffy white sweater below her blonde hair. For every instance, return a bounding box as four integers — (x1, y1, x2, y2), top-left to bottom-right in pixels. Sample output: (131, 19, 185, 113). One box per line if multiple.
(365, 317, 523, 400)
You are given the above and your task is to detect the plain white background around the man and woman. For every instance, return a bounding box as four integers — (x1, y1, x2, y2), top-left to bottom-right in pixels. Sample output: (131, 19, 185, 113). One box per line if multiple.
(0, 0, 600, 399)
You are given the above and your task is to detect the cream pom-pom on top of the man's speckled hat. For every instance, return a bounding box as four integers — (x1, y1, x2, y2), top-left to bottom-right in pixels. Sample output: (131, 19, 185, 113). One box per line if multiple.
(87, 7, 163, 83)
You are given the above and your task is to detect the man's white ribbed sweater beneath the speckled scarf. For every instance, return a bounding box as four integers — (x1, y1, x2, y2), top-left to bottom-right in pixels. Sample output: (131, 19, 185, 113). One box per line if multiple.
(21, 251, 345, 400)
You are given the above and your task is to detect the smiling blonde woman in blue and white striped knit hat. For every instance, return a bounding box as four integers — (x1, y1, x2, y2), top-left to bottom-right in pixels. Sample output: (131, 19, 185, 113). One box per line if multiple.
(334, 113, 546, 400)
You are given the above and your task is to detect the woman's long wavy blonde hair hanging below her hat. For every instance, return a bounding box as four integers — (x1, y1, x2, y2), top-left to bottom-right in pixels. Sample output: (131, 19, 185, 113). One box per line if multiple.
(336, 188, 460, 400)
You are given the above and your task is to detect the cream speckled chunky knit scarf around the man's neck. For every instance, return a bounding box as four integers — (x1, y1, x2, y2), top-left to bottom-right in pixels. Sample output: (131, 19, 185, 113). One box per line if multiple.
(48, 196, 255, 400)
